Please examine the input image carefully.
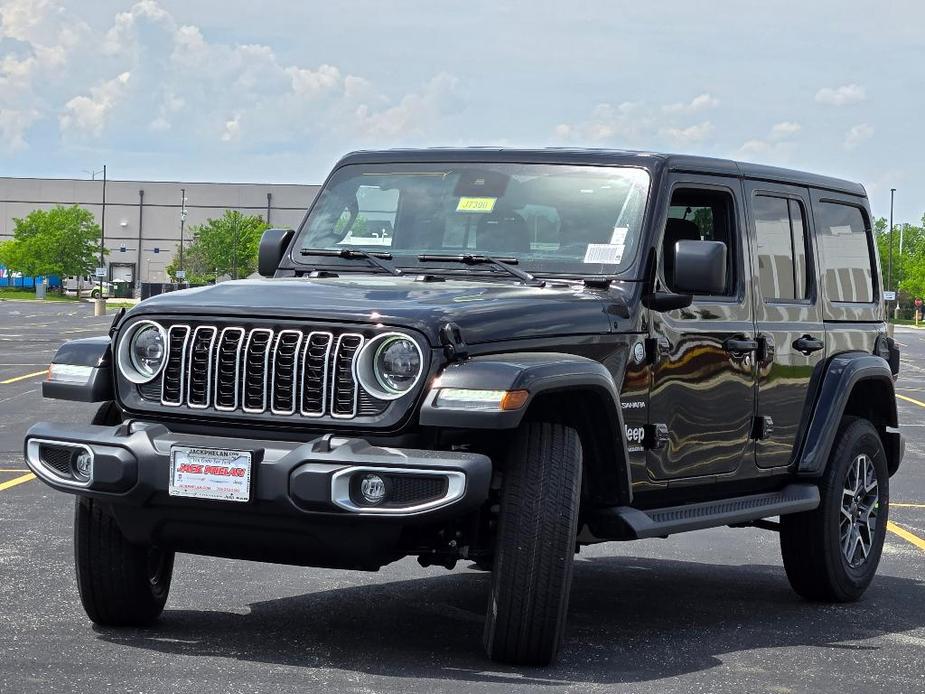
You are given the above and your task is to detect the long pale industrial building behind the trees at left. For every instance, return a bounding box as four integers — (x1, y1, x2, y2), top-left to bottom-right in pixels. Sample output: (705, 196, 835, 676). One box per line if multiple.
(0, 177, 319, 285)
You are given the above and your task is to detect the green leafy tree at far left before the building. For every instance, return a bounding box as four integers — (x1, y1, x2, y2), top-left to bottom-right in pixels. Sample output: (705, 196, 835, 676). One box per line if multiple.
(0, 205, 100, 277)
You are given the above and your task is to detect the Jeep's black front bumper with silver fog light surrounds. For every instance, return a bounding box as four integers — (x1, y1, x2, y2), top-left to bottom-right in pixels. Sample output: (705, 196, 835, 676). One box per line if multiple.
(24, 421, 491, 522)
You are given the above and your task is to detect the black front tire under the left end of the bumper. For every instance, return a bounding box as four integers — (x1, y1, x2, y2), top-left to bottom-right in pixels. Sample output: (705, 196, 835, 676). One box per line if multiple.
(74, 497, 174, 627)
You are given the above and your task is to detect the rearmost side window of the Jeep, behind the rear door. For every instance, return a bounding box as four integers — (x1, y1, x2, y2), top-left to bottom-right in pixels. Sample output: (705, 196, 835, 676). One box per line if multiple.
(816, 202, 874, 303)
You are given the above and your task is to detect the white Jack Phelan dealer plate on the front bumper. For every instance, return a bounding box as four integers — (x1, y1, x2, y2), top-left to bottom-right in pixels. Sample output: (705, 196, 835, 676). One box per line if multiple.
(168, 446, 251, 501)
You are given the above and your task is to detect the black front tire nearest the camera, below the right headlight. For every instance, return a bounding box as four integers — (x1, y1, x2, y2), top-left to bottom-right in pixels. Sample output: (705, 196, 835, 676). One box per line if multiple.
(484, 422, 581, 665)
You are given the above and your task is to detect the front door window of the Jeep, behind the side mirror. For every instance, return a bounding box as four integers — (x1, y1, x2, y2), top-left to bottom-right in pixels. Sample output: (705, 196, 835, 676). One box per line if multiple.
(662, 188, 739, 296)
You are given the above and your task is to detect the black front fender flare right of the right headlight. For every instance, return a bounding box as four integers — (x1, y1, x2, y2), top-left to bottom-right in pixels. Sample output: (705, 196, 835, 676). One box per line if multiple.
(419, 352, 632, 503)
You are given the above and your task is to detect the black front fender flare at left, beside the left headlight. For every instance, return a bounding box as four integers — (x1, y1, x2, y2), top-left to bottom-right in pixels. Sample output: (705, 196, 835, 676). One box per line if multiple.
(42, 335, 115, 402)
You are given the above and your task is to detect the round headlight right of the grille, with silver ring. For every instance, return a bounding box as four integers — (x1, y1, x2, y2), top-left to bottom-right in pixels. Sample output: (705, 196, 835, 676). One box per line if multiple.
(357, 333, 424, 400)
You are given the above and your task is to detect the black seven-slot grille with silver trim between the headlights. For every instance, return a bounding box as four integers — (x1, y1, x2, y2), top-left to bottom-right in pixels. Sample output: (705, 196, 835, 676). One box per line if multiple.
(149, 325, 386, 419)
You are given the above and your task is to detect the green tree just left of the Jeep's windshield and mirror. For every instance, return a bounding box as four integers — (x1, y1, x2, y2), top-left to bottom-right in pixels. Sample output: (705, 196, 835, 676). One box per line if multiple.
(166, 210, 267, 284)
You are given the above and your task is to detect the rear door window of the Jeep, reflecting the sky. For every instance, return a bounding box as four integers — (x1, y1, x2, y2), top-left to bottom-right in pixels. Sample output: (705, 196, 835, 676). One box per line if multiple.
(753, 195, 809, 301)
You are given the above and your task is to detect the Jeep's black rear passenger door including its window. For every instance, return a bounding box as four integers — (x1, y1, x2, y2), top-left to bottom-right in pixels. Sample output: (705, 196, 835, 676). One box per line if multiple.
(744, 181, 826, 468)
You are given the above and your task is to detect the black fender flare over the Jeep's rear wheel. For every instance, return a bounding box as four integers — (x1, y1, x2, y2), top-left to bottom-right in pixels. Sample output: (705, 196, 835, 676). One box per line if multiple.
(797, 352, 902, 477)
